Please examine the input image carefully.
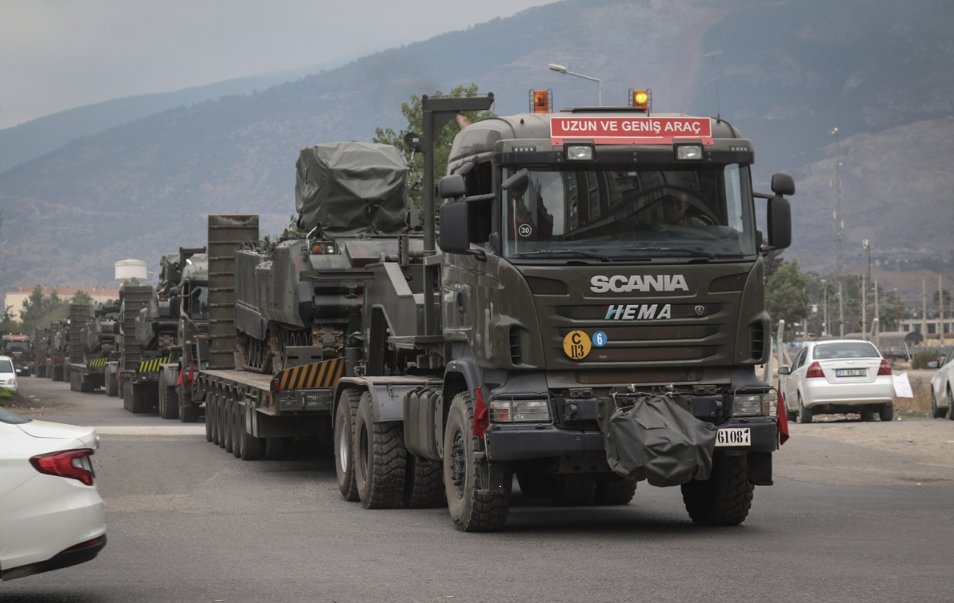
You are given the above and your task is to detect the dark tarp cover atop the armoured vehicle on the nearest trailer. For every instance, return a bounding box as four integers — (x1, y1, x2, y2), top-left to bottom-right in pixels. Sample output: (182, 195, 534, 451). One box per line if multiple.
(295, 142, 407, 236)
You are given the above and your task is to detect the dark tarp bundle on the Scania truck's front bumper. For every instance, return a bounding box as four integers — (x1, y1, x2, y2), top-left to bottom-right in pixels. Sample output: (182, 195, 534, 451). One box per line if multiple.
(604, 396, 718, 486)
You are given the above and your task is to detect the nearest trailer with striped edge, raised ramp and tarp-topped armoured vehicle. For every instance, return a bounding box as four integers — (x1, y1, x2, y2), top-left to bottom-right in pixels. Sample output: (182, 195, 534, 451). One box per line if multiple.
(193, 143, 414, 459)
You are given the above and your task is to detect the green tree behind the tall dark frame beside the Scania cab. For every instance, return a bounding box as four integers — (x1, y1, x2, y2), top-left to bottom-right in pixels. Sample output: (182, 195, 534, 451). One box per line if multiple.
(372, 84, 493, 215)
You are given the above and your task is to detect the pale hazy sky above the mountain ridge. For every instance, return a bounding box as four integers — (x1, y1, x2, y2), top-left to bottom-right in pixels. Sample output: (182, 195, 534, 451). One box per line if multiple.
(0, 0, 554, 128)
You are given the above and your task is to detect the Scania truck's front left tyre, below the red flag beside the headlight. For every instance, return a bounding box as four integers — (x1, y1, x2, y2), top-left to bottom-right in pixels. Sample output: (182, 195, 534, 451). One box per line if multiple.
(444, 391, 511, 532)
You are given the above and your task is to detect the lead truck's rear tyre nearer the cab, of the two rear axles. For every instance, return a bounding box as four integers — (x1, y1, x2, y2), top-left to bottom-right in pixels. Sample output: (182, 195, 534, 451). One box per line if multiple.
(354, 392, 407, 509)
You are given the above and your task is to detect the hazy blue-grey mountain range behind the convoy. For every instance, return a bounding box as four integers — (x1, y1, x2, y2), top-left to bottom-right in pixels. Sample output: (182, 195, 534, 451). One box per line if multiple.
(0, 0, 954, 302)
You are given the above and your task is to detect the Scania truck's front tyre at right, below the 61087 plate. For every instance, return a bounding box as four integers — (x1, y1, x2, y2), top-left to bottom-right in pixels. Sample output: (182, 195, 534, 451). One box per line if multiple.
(682, 455, 754, 526)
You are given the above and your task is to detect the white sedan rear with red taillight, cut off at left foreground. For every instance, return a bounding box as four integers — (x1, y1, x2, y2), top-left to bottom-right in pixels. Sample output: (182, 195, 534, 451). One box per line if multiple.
(0, 408, 106, 580)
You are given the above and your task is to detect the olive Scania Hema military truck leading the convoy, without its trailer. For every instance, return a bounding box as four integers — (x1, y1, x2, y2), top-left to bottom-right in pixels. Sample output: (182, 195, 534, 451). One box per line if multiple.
(324, 94, 794, 531)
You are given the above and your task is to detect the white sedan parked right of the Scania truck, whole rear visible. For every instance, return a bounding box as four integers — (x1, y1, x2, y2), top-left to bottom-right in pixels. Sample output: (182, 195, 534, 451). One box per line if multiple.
(778, 339, 894, 423)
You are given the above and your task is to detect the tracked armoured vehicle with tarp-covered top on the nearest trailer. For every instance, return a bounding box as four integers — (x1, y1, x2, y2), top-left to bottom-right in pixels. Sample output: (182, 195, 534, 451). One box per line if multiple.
(235, 142, 408, 373)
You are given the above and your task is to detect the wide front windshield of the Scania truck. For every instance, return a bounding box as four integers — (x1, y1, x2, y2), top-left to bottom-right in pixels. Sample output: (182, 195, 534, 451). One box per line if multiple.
(502, 164, 756, 260)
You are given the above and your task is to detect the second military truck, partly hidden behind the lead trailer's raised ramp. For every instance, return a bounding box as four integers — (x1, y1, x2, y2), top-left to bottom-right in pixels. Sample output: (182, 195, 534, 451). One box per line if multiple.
(156, 247, 209, 422)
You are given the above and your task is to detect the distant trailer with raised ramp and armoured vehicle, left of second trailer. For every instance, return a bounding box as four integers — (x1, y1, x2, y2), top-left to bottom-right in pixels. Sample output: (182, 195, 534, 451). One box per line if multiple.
(67, 301, 119, 393)
